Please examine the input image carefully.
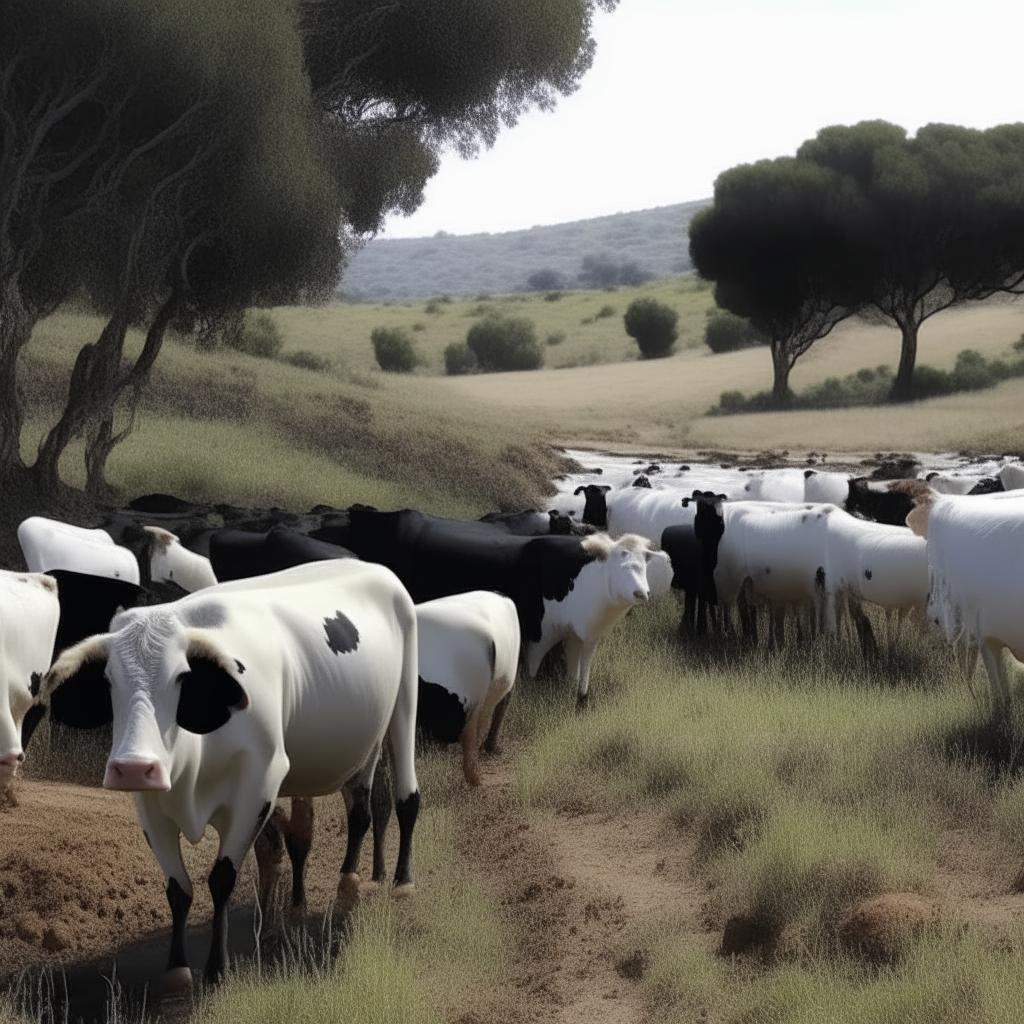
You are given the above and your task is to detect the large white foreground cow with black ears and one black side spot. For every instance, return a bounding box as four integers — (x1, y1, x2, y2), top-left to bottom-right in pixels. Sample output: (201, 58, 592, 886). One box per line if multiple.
(41, 560, 420, 987)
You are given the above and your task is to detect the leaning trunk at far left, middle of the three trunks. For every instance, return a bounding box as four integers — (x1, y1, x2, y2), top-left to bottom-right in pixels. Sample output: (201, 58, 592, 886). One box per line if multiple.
(32, 313, 128, 495)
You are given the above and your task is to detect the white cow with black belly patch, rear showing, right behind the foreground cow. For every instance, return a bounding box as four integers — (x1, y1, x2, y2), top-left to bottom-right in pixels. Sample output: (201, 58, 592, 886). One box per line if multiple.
(416, 590, 519, 785)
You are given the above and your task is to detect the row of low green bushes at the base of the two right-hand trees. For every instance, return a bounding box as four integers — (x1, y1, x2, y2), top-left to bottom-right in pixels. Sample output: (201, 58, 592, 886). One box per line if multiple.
(708, 348, 1024, 416)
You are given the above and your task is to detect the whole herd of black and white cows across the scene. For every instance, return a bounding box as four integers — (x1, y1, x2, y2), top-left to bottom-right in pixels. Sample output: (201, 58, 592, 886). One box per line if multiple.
(6, 465, 1024, 989)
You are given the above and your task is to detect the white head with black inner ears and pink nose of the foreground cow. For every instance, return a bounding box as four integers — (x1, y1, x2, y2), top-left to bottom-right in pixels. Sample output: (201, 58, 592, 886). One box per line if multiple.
(40, 607, 249, 791)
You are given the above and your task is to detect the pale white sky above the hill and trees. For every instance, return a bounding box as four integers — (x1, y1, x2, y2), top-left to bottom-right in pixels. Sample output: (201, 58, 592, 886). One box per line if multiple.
(381, 0, 1024, 238)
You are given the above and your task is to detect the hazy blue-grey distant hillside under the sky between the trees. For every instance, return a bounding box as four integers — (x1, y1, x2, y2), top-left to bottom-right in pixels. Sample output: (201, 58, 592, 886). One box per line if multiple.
(340, 199, 711, 298)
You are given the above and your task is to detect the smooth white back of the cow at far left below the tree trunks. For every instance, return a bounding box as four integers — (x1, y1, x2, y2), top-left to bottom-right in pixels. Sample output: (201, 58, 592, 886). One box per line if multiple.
(17, 516, 139, 586)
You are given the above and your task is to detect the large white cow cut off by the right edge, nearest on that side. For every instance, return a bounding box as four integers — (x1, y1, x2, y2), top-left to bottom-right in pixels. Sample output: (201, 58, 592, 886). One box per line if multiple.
(907, 493, 1024, 718)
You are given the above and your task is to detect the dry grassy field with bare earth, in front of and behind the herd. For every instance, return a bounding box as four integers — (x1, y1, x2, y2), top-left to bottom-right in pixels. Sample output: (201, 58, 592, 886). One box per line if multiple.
(6, 279, 1024, 1024)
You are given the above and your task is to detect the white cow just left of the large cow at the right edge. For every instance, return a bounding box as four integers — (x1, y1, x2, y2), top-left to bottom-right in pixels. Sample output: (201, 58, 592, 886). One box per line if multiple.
(825, 510, 928, 655)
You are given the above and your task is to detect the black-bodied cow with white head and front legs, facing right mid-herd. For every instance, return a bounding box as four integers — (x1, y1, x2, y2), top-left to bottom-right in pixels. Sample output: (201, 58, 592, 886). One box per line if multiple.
(316, 506, 670, 702)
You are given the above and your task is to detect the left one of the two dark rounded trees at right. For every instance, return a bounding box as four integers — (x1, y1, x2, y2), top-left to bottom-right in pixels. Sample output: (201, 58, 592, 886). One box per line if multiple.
(689, 157, 864, 408)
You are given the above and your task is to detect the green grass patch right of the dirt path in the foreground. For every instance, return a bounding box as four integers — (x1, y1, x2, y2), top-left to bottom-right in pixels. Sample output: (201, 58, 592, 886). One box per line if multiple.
(509, 598, 1024, 1024)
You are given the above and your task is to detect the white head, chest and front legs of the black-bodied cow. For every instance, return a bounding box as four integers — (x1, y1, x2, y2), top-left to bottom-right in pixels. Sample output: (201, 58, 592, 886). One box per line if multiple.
(524, 534, 672, 699)
